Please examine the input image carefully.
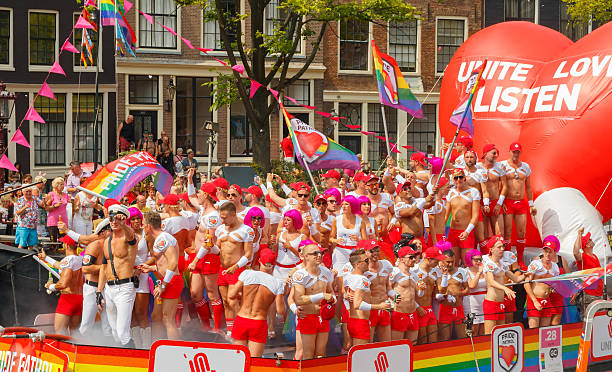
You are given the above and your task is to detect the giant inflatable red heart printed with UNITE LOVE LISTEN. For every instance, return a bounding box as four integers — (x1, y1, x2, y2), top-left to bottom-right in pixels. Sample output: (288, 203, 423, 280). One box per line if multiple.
(439, 22, 612, 251)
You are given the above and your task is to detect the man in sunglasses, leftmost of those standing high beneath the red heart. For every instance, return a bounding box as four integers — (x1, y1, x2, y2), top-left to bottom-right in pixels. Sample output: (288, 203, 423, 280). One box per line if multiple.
(444, 168, 480, 266)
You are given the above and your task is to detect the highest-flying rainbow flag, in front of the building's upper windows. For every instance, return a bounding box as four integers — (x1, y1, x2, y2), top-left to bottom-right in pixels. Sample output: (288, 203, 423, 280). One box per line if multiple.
(372, 40, 423, 118)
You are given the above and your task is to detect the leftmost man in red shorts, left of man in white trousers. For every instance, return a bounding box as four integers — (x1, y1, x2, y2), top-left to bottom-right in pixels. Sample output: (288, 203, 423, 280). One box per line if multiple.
(38, 236, 83, 336)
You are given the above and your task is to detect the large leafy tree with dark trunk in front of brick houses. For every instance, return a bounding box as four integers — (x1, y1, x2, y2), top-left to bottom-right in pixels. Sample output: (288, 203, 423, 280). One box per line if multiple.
(177, 0, 418, 170)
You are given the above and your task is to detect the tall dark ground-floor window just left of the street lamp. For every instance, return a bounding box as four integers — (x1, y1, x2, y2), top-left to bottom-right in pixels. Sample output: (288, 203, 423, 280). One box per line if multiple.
(176, 77, 212, 156)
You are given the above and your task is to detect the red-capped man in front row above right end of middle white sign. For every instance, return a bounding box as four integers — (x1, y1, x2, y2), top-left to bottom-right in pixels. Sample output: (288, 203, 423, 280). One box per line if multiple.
(389, 246, 425, 344)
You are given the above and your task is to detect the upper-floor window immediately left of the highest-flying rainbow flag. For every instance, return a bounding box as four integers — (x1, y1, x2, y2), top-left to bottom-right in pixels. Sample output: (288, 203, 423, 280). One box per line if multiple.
(339, 19, 370, 70)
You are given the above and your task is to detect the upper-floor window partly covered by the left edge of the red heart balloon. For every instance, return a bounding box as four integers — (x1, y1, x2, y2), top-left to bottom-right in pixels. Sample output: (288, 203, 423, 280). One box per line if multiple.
(436, 19, 466, 73)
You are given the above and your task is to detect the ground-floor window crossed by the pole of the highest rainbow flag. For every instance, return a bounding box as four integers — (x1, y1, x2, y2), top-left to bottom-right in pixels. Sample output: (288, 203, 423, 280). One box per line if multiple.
(367, 103, 397, 169)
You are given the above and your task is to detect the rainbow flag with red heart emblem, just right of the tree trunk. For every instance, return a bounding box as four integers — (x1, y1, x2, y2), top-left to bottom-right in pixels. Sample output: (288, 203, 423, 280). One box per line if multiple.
(279, 102, 361, 169)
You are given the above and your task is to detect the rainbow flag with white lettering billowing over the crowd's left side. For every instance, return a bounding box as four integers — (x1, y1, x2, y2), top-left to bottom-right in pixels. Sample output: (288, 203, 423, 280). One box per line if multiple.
(81, 151, 172, 199)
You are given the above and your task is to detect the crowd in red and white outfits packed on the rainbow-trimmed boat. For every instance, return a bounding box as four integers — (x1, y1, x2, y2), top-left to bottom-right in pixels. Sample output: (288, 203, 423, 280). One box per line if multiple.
(22, 137, 602, 359)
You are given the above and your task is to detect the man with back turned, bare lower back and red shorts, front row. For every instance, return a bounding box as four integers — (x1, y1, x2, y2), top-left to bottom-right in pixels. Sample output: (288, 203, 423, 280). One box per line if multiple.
(228, 265, 286, 357)
